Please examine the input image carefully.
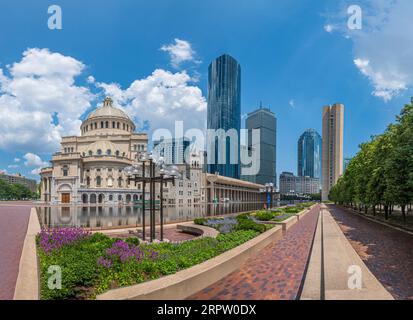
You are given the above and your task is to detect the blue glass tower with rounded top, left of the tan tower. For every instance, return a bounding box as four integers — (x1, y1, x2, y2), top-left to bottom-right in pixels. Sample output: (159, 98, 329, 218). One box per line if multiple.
(297, 129, 322, 179)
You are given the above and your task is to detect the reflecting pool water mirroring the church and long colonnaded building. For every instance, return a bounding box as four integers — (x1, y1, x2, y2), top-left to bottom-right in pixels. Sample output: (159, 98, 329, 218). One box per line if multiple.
(37, 202, 263, 229)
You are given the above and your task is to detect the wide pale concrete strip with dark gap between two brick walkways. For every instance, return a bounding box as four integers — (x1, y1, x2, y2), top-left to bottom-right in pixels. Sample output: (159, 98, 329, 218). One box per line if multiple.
(301, 206, 393, 300)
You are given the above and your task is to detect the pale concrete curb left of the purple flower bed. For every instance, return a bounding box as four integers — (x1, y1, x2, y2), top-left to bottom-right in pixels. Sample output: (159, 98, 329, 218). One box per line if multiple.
(13, 208, 40, 300)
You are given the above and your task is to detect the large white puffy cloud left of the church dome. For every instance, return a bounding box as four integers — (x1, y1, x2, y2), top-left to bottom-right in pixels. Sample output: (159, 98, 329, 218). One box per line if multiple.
(0, 48, 94, 152)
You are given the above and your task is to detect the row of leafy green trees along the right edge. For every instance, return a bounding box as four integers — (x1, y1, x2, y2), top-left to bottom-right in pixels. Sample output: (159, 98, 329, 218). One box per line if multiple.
(329, 98, 413, 221)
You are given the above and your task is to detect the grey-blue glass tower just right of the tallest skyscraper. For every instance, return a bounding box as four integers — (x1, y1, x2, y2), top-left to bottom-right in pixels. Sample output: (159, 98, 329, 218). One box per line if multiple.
(242, 106, 277, 186)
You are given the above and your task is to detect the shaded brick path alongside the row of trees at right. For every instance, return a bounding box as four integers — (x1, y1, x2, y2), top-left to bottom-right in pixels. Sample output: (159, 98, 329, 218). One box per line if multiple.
(329, 205, 413, 300)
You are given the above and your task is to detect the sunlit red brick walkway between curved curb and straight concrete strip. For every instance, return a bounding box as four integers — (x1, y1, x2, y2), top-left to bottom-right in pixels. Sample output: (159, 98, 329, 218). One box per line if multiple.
(188, 206, 319, 300)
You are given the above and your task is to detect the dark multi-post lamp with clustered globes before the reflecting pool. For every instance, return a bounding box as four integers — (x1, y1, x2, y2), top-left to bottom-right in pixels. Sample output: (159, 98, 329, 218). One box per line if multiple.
(124, 152, 179, 242)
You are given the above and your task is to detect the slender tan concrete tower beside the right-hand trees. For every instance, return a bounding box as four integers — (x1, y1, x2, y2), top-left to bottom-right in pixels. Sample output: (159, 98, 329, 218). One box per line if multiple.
(322, 103, 344, 200)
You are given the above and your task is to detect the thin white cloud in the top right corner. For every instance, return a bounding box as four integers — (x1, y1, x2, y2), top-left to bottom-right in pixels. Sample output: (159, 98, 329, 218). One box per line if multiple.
(326, 0, 413, 101)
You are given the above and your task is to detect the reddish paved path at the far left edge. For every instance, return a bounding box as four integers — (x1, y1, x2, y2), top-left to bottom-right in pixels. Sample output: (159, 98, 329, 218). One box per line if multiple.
(0, 203, 31, 300)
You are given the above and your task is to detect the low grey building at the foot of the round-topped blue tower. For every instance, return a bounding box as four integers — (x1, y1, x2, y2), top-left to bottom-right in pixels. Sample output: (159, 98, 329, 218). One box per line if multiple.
(280, 172, 320, 195)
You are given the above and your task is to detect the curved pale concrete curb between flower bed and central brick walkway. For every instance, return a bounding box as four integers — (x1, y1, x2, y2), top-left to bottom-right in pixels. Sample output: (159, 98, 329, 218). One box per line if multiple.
(96, 226, 282, 300)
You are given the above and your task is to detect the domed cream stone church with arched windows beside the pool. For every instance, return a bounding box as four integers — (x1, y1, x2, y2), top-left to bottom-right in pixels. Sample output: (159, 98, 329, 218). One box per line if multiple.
(40, 97, 148, 205)
